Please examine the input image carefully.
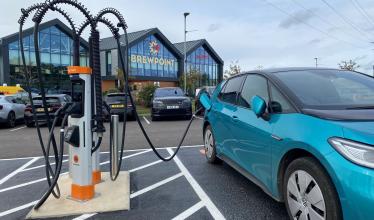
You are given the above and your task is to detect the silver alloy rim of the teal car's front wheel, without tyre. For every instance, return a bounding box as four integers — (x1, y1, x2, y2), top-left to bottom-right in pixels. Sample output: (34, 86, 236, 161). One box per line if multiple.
(287, 170, 326, 220)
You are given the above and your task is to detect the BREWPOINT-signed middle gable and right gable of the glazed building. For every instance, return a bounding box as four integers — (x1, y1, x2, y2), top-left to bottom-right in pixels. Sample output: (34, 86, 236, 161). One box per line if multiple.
(100, 28, 223, 93)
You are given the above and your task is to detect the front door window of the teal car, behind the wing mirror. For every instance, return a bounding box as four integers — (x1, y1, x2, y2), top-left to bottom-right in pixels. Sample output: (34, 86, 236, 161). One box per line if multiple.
(238, 74, 269, 108)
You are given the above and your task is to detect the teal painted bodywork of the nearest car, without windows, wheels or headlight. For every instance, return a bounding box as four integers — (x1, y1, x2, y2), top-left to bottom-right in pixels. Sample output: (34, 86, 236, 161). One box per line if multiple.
(204, 69, 374, 219)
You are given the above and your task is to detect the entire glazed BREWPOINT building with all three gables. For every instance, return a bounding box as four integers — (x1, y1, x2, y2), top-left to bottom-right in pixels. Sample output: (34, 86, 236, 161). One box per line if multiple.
(0, 19, 223, 92)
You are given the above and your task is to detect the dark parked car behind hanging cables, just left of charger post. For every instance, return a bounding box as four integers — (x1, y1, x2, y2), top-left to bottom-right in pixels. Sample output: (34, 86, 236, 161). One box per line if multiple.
(25, 94, 72, 127)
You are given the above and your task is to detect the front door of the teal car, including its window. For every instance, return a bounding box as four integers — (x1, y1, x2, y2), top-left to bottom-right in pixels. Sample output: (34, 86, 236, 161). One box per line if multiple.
(231, 74, 273, 186)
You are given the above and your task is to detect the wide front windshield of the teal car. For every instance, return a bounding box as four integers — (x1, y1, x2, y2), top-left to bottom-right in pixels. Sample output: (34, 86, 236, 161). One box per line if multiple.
(274, 70, 374, 110)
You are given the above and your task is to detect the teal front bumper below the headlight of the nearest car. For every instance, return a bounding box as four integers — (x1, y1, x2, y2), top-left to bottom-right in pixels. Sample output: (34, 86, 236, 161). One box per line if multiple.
(326, 152, 374, 220)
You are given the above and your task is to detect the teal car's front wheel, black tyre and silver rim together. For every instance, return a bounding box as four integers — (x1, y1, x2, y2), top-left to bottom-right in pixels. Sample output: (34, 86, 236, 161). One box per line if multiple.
(283, 157, 342, 220)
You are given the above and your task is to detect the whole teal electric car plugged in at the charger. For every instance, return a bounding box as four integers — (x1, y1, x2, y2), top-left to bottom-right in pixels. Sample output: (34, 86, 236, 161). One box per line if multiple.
(200, 68, 374, 220)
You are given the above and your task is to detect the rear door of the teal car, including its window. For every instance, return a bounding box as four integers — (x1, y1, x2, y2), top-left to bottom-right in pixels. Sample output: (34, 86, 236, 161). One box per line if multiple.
(211, 75, 245, 159)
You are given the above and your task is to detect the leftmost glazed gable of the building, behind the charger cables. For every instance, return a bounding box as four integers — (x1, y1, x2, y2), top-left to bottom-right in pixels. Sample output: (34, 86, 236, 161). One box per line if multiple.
(0, 19, 88, 91)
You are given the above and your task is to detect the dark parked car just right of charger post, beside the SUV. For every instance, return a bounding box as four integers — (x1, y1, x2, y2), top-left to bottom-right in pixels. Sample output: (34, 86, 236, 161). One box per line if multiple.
(105, 93, 134, 118)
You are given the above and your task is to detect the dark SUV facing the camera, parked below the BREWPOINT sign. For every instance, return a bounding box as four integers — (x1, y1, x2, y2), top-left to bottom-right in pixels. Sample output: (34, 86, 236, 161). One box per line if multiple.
(151, 87, 192, 121)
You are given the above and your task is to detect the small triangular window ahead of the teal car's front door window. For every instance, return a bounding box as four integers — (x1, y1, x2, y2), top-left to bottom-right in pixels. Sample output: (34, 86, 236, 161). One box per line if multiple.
(269, 84, 295, 113)
